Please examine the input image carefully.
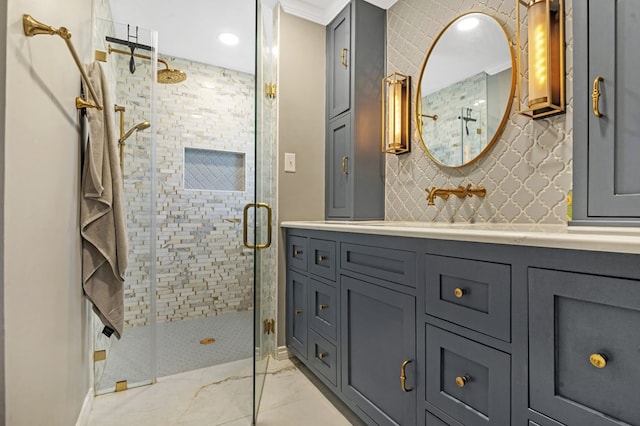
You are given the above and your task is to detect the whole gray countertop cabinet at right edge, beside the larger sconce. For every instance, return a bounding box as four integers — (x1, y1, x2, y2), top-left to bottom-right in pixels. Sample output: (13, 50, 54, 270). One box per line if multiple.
(573, 0, 640, 226)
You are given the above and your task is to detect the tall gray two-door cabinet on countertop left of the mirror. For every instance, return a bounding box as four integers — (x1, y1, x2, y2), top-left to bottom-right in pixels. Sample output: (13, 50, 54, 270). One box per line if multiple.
(325, 0, 386, 220)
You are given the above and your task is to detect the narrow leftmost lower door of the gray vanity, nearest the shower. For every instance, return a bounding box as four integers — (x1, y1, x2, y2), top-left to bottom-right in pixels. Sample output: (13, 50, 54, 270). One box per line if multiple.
(287, 270, 309, 359)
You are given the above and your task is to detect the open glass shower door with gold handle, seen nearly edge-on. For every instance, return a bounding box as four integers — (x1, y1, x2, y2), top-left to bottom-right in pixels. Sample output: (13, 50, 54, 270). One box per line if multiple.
(254, 0, 278, 424)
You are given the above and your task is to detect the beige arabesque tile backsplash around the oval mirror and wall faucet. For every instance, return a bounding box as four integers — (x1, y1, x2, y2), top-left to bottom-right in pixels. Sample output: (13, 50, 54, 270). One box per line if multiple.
(385, 0, 573, 223)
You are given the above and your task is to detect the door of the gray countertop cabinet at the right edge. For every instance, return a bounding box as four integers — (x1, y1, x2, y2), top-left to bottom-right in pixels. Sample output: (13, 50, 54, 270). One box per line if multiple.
(580, 0, 640, 217)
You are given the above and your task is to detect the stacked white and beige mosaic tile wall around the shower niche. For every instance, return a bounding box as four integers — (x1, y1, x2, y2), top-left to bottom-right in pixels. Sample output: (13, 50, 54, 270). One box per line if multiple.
(118, 55, 255, 326)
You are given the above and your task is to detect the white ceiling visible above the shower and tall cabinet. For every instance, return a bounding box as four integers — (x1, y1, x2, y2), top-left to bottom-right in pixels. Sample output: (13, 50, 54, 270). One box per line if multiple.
(110, 0, 397, 74)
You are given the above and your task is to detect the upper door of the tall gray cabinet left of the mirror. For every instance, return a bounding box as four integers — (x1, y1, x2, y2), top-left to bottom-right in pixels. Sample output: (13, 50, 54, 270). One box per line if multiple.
(327, 5, 351, 118)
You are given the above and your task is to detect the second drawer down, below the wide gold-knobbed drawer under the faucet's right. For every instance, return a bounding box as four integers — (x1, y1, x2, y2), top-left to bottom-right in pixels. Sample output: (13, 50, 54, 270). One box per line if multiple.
(425, 324, 511, 425)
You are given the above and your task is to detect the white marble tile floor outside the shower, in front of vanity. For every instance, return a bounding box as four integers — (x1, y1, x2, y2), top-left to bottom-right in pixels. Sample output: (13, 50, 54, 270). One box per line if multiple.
(81, 358, 362, 426)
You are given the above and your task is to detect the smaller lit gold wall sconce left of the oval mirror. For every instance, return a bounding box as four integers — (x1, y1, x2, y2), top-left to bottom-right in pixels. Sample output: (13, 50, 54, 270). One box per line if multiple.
(382, 72, 411, 154)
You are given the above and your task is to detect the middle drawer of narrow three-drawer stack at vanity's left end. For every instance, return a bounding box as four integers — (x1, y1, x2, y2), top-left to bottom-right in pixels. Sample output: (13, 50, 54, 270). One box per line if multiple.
(309, 279, 338, 341)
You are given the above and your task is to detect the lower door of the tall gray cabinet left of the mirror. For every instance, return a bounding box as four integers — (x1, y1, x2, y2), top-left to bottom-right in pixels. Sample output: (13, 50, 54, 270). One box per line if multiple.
(326, 114, 353, 218)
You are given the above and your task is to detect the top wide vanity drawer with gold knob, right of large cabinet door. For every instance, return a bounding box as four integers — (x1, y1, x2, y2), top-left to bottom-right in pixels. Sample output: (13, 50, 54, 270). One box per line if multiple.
(425, 254, 511, 342)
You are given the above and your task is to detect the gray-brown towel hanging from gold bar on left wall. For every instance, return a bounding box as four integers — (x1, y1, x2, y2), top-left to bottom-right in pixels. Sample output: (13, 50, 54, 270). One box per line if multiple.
(80, 62, 127, 339)
